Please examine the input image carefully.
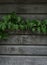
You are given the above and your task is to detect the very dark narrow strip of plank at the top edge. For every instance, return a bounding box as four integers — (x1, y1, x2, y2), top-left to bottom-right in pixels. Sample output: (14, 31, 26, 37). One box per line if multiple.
(0, 0, 47, 3)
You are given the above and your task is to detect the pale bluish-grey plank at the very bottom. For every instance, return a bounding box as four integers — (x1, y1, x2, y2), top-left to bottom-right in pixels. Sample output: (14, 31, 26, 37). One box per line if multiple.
(0, 56, 47, 65)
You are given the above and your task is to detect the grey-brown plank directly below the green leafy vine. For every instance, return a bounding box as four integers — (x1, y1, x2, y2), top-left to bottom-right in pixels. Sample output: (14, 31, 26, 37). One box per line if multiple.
(0, 35, 47, 44)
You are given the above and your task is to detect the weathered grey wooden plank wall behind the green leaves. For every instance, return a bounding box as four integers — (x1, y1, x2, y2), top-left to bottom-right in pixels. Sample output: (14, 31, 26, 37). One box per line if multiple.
(0, 0, 47, 65)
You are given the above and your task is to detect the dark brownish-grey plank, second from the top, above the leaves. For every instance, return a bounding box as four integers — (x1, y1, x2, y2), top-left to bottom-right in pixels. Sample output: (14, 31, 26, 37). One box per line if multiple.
(0, 4, 47, 13)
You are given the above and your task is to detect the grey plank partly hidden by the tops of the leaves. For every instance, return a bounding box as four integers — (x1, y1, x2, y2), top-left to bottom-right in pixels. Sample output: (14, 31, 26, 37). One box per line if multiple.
(0, 14, 47, 20)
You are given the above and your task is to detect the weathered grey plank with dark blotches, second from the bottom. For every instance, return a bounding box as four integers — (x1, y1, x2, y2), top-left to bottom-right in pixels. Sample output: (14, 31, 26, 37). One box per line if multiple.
(0, 46, 47, 55)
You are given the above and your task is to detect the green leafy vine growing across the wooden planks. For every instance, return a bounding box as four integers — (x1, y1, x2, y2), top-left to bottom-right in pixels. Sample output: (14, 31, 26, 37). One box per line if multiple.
(0, 13, 47, 39)
